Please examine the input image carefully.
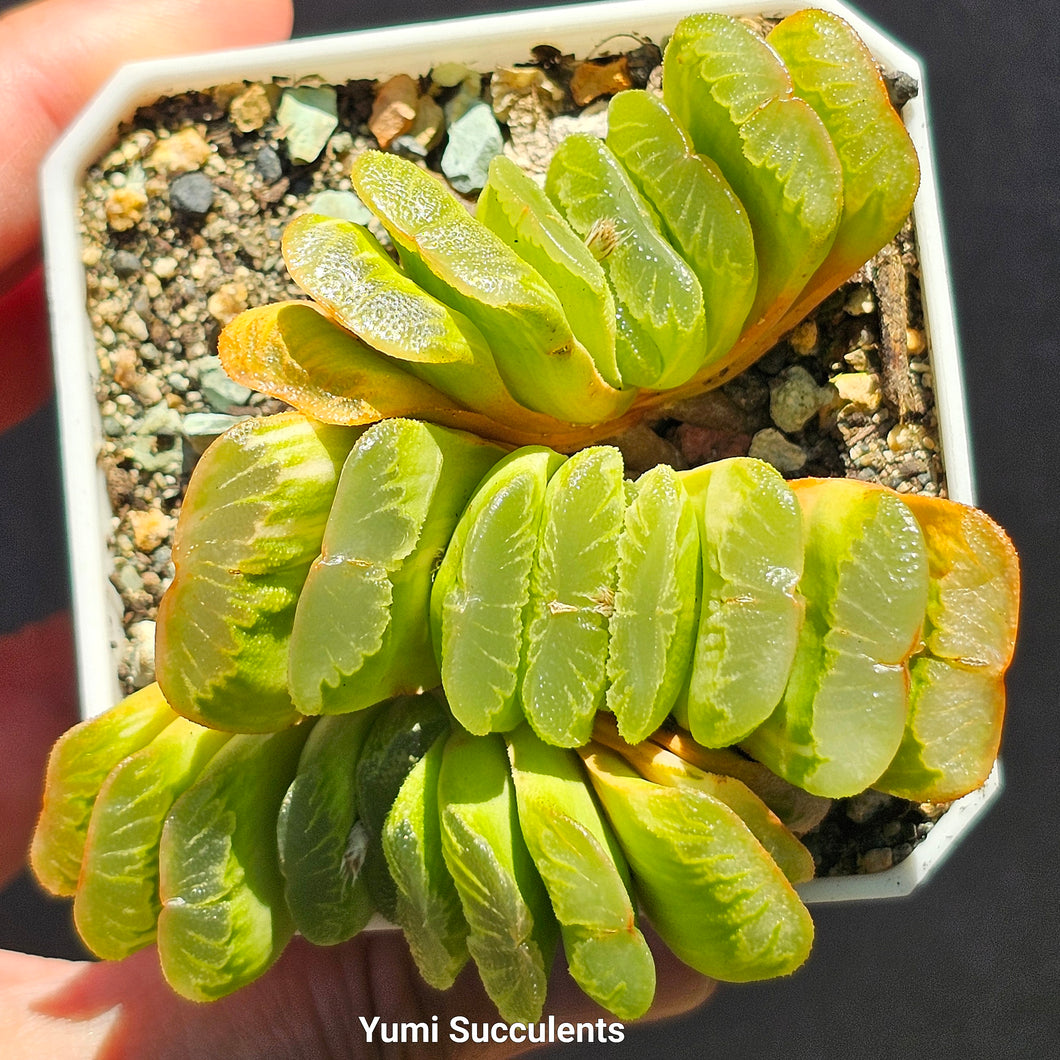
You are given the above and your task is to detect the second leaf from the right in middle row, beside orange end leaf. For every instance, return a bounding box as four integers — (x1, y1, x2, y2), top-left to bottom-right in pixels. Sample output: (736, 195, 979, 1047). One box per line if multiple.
(743, 479, 928, 797)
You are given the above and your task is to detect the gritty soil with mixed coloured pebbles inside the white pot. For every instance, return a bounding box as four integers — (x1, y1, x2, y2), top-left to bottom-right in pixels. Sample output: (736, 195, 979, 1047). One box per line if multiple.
(81, 26, 946, 875)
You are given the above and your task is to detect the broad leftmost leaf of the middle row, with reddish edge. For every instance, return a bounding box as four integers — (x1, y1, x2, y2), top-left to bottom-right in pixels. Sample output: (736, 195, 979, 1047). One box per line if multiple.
(155, 412, 360, 731)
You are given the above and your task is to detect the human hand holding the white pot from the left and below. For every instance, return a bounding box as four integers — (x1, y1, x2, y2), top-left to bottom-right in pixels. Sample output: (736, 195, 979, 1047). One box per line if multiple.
(0, 0, 712, 1060)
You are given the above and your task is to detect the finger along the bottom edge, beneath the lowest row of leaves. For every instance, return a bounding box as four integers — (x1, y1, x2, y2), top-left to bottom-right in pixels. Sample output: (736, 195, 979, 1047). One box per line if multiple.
(0, 932, 713, 1060)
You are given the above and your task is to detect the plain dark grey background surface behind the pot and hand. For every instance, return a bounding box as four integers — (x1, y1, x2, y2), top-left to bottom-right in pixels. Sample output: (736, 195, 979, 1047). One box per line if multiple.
(0, 0, 1060, 1060)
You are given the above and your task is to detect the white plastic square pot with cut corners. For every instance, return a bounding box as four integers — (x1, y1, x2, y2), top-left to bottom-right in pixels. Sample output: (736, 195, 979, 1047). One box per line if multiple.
(41, 0, 1001, 901)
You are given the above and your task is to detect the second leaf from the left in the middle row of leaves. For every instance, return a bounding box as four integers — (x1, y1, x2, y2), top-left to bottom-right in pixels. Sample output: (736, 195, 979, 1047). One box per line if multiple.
(289, 420, 501, 714)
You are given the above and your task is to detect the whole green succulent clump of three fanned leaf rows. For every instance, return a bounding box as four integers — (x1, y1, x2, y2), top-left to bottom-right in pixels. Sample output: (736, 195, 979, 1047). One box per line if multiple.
(32, 12, 1019, 1022)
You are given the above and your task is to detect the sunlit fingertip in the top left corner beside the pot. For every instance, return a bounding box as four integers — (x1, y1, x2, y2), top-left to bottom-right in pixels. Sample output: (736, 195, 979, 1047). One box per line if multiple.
(0, 0, 293, 286)
